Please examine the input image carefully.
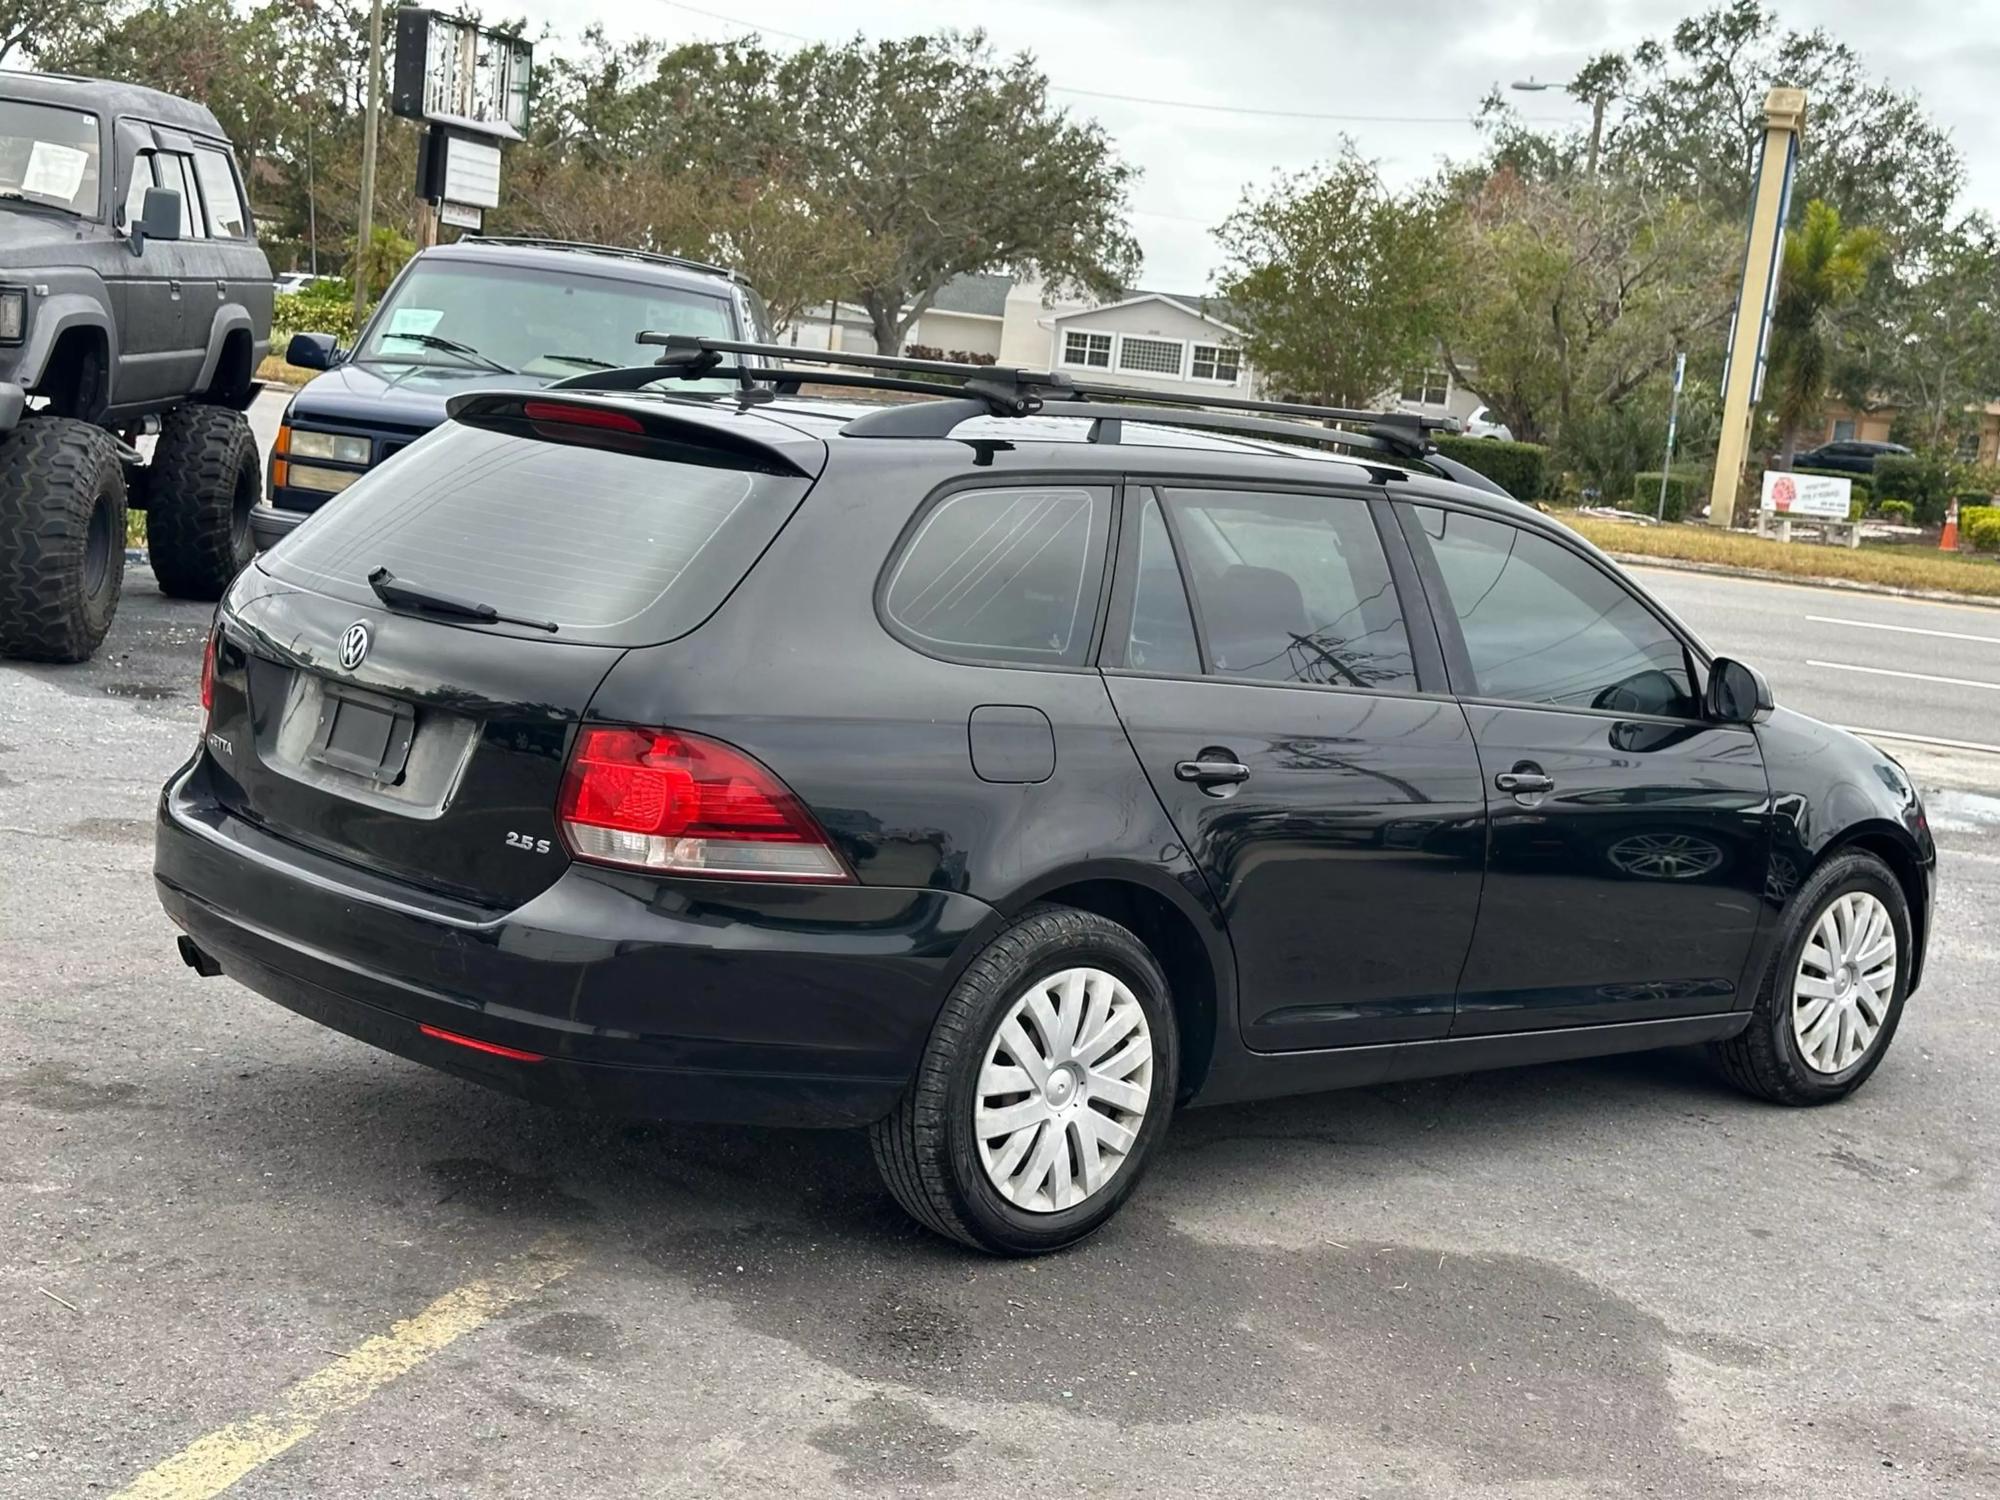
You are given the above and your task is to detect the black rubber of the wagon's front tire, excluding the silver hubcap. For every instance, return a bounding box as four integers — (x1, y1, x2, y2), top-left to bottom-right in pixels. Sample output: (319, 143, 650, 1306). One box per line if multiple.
(1708, 850, 1916, 1104)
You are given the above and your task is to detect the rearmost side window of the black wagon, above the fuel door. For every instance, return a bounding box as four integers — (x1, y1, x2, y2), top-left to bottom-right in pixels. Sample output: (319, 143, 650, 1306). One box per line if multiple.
(884, 486, 1110, 666)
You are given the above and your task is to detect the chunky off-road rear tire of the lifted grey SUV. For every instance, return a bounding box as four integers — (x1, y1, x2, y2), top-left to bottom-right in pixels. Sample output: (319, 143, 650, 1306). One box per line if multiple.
(146, 404, 264, 600)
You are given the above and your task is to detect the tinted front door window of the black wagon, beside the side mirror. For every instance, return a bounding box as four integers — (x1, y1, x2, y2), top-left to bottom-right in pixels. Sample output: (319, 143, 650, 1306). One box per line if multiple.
(1418, 506, 1694, 716)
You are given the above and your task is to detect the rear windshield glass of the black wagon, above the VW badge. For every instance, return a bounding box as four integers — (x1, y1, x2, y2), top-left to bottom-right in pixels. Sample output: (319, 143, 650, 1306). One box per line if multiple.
(264, 424, 810, 646)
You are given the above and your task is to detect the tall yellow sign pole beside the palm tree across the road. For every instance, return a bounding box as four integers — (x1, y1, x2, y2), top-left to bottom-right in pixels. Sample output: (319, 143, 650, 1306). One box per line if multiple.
(1708, 88, 1806, 526)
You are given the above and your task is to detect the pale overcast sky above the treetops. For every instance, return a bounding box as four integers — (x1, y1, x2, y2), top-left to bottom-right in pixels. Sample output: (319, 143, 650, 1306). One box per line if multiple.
(486, 0, 2000, 292)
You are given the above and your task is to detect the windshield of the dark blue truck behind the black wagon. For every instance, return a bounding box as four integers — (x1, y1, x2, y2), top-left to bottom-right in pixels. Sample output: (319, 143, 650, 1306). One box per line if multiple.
(354, 256, 736, 386)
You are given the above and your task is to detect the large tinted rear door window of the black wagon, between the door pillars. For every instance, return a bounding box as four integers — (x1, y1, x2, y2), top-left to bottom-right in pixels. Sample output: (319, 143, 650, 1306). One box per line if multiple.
(1168, 490, 1416, 692)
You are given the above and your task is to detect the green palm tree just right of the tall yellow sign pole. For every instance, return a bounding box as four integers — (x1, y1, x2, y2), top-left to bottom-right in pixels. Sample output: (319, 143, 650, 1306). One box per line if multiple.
(1766, 198, 1884, 468)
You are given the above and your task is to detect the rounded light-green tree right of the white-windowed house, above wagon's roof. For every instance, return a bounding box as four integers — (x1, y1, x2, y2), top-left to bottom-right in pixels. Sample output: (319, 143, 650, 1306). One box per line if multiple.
(1216, 142, 1442, 406)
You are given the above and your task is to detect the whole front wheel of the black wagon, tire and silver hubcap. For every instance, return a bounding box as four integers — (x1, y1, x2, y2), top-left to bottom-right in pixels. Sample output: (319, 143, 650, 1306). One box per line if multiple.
(1712, 850, 1916, 1104)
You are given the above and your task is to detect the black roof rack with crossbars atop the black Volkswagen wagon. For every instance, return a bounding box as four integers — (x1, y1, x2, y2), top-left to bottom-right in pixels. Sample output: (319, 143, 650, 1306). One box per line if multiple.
(554, 330, 1486, 478)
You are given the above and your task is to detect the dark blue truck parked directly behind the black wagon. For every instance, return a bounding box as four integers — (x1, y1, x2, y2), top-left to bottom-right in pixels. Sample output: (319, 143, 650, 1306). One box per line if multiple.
(250, 238, 770, 548)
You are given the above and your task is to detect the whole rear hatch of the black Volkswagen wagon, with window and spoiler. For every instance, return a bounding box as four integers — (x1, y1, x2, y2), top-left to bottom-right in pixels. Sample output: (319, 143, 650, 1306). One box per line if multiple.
(206, 394, 824, 908)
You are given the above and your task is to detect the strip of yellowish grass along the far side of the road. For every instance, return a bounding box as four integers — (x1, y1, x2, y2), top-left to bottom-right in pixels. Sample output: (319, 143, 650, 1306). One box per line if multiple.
(1556, 510, 2000, 600)
